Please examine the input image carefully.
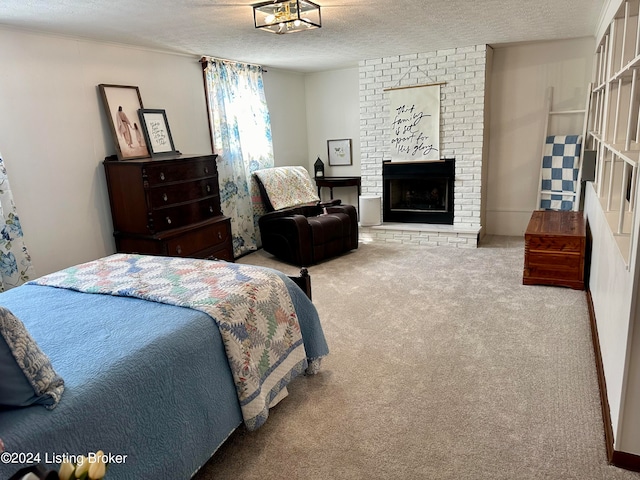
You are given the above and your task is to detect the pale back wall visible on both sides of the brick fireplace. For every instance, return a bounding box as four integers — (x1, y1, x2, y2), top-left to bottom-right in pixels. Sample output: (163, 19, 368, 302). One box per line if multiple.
(300, 38, 595, 242)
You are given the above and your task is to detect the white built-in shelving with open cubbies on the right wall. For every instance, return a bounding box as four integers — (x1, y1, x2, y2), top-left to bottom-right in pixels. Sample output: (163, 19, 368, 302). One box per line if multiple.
(587, 0, 640, 264)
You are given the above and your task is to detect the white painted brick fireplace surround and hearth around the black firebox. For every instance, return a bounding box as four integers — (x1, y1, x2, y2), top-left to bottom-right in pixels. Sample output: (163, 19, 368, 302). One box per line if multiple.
(359, 45, 492, 248)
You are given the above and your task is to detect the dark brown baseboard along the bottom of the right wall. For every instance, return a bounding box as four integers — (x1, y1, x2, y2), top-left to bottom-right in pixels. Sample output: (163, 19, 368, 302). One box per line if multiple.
(587, 289, 640, 472)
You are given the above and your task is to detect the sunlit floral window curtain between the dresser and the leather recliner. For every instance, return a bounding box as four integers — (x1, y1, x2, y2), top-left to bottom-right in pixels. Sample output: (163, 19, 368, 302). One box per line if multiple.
(205, 59, 273, 257)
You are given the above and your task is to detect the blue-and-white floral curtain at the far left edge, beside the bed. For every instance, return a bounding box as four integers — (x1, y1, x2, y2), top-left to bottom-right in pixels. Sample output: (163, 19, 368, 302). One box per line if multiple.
(0, 155, 35, 292)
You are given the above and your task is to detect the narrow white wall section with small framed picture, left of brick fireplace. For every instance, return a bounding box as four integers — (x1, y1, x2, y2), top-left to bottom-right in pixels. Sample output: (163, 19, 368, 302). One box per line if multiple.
(305, 67, 360, 206)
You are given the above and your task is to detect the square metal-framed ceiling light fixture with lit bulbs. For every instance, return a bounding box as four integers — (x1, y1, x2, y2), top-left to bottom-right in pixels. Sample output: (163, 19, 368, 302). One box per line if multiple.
(252, 0, 322, 34)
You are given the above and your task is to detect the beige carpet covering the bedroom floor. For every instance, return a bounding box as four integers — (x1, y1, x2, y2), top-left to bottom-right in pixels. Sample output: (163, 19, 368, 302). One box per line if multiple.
(195, 237, 640, 480)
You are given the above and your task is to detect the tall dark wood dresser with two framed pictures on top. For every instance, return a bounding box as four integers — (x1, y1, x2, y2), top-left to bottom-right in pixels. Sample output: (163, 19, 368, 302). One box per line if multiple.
(104, 155, 234, 262)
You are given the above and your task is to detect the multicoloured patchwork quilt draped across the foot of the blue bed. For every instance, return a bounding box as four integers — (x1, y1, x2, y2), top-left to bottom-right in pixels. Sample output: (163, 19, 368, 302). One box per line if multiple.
(29, 254, 307, 430)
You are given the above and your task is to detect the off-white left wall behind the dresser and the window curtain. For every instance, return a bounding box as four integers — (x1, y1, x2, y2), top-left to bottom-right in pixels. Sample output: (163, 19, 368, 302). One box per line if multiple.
(0, 28, 308, 275)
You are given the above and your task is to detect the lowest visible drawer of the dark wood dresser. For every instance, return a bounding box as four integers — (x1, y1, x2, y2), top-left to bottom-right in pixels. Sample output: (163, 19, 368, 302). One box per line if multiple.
(167, 220, 233, 260)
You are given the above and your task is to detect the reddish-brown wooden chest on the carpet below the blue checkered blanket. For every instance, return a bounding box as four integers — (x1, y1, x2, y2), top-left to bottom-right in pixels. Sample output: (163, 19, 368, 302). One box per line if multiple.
(522, 210, 586, 290)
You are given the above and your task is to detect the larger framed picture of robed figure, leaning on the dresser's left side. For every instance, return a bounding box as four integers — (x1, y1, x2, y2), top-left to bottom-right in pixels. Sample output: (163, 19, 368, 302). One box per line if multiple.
(98, 83, 149, 160)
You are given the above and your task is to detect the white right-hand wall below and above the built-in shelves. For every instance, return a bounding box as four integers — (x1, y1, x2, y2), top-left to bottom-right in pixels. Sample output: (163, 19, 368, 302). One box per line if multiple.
(585, 0, 640, 455)
